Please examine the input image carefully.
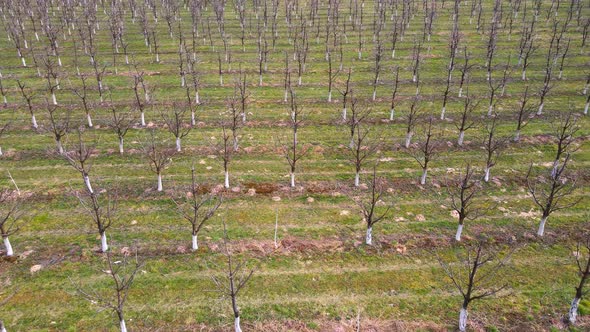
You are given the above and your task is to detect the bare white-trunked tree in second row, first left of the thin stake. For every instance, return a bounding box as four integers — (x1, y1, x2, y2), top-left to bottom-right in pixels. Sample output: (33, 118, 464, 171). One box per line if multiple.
(173, 166, 222, 251)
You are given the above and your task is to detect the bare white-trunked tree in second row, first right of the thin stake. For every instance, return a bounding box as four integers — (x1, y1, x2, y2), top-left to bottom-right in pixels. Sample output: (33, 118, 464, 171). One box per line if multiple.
(354, 165, 391, 246)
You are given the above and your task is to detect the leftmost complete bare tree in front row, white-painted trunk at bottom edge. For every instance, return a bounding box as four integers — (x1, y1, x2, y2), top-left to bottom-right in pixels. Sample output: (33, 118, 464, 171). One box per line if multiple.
(70, 248, 144, 332)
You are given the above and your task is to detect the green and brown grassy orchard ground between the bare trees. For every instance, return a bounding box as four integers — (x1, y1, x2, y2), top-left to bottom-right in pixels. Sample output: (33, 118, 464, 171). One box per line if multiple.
(0, 0, 590, 331)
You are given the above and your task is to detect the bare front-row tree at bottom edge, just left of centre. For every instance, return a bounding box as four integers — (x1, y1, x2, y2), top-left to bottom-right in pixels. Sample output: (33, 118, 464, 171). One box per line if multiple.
(211, 220, 255, 332)
